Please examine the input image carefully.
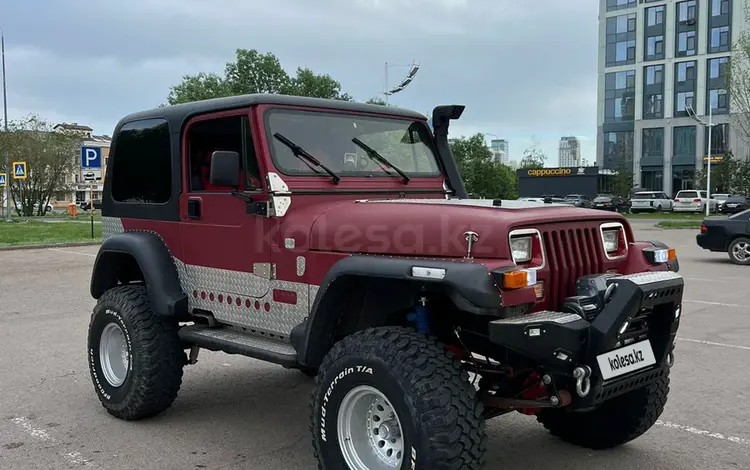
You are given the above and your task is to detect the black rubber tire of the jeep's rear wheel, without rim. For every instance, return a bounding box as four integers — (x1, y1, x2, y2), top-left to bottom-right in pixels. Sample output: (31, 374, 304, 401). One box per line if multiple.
(89, 285, 187, 421)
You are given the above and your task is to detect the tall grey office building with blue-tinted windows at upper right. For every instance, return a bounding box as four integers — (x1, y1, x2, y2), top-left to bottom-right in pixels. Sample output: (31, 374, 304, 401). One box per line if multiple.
(596, 0, 750, 195)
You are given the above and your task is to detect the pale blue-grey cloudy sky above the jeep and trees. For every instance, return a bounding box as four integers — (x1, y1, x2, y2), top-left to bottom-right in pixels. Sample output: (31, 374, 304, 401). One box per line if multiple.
(0, 0, 598, 166)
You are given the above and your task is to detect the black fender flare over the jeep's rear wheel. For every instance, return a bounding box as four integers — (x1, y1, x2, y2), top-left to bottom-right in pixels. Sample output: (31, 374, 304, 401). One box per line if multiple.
(90, 232, 188, 316)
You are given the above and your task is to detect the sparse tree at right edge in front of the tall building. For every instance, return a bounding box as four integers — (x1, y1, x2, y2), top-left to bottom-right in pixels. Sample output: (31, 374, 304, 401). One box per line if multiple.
(725, 7, 750, 143)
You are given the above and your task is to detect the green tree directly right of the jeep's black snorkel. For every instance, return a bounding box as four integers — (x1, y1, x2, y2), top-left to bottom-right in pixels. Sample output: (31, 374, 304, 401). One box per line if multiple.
(451, 134, 518, 199)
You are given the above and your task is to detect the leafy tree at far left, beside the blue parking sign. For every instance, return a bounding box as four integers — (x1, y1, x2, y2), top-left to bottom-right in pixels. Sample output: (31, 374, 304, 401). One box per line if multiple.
(0, 115, 83, 217)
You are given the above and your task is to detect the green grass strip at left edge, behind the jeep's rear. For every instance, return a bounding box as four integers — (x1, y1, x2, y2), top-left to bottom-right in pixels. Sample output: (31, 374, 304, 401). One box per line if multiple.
(0, 221, 102, 246)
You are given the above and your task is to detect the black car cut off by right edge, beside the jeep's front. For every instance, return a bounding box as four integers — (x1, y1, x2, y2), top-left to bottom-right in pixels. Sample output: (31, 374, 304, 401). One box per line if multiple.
(695, 209, 750, 266)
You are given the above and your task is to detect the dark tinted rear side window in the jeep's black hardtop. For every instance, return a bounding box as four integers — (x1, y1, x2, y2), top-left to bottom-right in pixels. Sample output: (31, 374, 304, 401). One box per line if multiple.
(109, 119, 172, 204)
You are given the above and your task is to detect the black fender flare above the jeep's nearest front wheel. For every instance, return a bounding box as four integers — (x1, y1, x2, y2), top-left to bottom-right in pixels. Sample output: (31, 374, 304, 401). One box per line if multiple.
(290, 255, 502, 366)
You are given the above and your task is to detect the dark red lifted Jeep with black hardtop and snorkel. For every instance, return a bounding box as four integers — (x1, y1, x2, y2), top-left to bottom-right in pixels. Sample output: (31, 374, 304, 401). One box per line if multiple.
(88, 95, 683, 470)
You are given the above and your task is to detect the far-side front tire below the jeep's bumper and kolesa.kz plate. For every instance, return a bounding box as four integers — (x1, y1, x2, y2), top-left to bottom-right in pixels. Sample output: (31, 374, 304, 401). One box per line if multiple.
(537, 367, 669, 450)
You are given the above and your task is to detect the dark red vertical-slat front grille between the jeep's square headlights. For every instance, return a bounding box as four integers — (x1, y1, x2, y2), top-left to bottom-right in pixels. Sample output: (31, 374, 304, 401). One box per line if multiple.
(541, 227, 604, 310)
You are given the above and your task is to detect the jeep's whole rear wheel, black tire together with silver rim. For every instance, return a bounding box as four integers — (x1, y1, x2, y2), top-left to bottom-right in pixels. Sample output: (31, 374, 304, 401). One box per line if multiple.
(88, 286, 187, 421)
